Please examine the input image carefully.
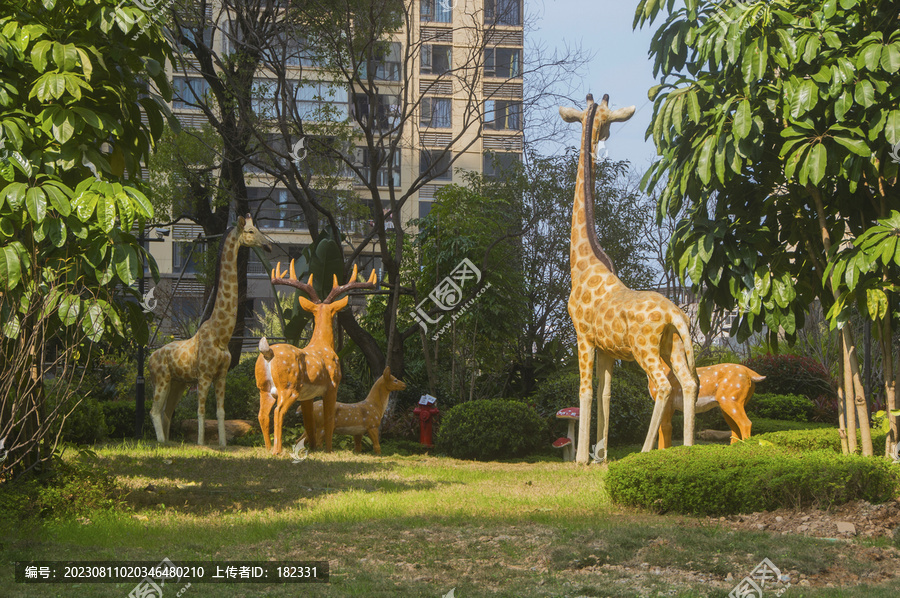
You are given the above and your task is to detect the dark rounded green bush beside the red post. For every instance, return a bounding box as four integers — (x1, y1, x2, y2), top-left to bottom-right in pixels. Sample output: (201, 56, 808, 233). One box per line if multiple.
(435, 399, 546, 461)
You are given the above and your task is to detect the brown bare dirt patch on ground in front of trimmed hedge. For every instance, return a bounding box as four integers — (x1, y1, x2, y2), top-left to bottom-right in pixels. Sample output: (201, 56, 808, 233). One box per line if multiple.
(708, 498, 900, 539)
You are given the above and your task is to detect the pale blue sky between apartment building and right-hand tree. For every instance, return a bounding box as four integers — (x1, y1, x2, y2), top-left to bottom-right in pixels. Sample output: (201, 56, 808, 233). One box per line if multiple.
(525, 0, 659, 173)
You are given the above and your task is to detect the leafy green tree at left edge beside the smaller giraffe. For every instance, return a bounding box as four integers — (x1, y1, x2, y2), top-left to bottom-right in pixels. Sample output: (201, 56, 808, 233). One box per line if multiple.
(0, 0, 170, 479)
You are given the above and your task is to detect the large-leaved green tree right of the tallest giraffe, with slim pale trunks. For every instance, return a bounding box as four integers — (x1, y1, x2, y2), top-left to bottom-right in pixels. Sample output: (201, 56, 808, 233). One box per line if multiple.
(635, 0, 900, 454)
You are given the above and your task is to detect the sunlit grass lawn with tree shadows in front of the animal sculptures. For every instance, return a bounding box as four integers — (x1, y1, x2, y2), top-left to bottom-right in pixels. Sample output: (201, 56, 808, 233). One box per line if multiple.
(0, 441, 900, 598)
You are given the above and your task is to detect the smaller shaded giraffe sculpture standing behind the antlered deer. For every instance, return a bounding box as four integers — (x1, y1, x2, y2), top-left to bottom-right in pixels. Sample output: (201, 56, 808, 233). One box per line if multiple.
(149, 214, 271, 446)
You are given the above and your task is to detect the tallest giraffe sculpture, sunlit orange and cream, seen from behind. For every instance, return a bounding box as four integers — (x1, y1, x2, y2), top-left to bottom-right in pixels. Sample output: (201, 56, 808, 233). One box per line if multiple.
(559, 95, 698, 463)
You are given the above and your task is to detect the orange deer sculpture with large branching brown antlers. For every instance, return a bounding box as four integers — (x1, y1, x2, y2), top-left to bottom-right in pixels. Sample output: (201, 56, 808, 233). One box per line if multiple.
(256, 260, 376, 455)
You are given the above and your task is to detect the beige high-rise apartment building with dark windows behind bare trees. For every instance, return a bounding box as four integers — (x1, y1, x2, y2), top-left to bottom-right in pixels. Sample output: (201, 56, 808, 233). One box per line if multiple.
(148, 0, 524, 334)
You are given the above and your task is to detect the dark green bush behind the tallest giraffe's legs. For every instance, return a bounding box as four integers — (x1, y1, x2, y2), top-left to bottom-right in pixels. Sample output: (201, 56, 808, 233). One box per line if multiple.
(531, 363, 653, 446)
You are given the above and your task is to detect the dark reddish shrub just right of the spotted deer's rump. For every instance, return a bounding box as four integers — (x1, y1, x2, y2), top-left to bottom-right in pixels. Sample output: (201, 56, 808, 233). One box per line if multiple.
(745, 355, 836, 400)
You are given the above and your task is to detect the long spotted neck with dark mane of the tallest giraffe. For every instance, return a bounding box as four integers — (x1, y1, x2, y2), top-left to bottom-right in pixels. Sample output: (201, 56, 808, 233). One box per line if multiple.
(569, 104, 616, 275)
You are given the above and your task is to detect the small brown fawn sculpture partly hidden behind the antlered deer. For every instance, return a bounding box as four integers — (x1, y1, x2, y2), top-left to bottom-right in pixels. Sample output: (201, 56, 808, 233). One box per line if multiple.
(303, 367, 406, 455)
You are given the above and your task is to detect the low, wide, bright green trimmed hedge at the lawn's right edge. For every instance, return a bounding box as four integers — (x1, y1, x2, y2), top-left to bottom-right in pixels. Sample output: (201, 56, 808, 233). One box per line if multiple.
(606, 440, 900, 515)
